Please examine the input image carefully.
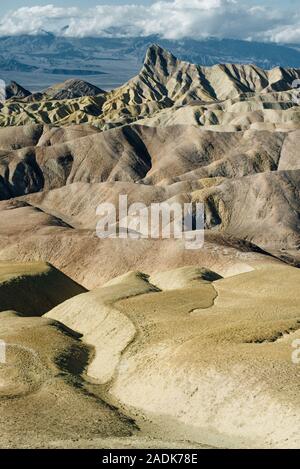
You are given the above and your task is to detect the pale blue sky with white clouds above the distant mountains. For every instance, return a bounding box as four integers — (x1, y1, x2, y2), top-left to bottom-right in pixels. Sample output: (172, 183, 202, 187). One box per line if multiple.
(0, 0, 300, 44)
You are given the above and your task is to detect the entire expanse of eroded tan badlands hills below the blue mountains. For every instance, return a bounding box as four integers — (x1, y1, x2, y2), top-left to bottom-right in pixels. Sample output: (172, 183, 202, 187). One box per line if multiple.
(0, 45, 300, 448)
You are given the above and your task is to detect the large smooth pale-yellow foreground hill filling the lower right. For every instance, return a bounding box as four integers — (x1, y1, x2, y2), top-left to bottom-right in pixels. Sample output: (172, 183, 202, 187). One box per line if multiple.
(46, 265, 300, 448)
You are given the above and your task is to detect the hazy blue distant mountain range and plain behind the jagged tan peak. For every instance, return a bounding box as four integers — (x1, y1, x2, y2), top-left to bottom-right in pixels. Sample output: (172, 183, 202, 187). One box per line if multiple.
(0, 32, 300, 91)
